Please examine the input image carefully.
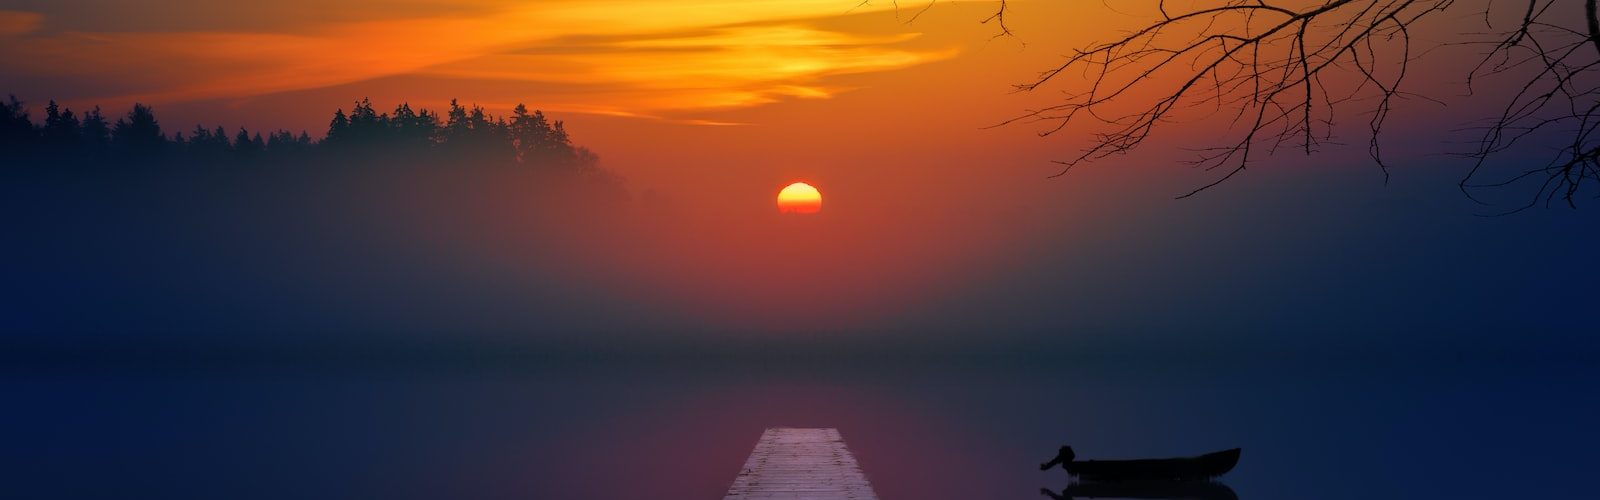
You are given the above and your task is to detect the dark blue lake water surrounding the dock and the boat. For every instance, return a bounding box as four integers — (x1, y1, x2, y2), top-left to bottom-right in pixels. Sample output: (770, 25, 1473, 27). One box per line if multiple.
(0, 350, 1600, 498)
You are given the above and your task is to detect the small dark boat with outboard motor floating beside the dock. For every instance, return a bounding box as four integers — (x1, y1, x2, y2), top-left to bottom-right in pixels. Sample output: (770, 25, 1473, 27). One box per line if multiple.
(1038, 446, 1240, 482)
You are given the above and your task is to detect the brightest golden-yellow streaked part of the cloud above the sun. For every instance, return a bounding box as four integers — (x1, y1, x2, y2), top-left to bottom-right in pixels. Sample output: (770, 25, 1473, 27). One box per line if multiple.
(421, 24, 954, 111)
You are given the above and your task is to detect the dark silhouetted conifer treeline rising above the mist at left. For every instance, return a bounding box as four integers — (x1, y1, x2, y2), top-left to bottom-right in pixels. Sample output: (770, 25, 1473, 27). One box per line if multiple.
(0, 96, 610, 176)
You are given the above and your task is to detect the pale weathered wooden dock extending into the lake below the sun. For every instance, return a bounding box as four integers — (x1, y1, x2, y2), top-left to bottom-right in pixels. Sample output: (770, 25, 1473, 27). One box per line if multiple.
(723, 428, 878, 500)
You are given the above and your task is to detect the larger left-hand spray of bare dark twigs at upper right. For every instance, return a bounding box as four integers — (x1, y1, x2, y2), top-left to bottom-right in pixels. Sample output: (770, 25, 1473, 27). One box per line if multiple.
(1006, 0, 1451, 197)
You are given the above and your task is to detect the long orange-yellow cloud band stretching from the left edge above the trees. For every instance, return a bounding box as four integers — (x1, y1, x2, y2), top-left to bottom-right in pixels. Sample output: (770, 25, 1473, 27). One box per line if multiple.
(0, 0, 954, 115)
